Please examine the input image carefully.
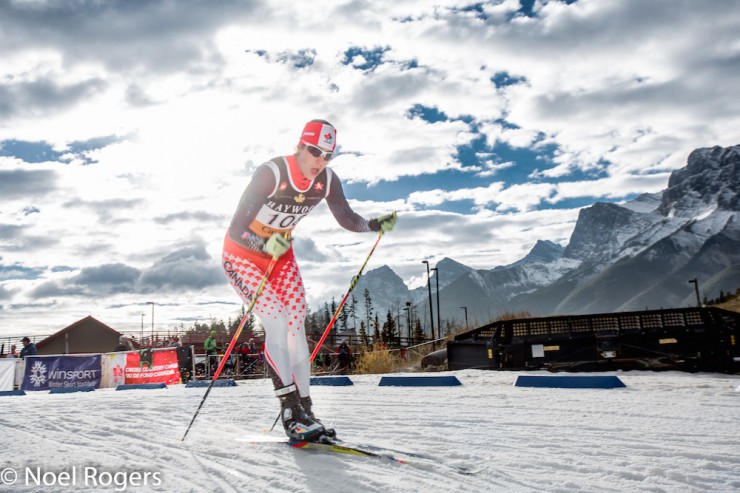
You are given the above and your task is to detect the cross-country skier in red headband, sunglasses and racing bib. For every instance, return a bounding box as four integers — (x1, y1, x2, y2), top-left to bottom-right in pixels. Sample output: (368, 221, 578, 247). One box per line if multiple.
(223, 120, 396, 441)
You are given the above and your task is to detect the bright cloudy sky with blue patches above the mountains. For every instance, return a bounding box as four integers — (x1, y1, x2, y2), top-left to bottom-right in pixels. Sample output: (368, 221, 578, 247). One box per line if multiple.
(0, 0, 740, 335)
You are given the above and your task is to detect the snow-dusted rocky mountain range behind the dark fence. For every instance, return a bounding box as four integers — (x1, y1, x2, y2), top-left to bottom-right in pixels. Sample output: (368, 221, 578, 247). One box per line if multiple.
(344, 145, 740, 327)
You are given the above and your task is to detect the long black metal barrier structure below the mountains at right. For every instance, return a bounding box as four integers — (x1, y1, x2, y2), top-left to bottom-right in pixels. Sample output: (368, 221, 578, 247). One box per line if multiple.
(447, 308, 740, 373)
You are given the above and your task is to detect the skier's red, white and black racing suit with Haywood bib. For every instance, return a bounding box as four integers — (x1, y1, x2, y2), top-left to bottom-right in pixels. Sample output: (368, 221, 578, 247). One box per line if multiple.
(223, 156, 379, 397)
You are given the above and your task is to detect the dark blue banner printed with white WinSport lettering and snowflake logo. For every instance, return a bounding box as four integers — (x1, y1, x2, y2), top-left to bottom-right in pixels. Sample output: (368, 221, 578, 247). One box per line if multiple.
(21, 354, 102, 390)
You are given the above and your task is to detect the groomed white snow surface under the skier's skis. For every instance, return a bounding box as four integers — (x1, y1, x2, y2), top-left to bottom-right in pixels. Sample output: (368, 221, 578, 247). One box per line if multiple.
(0, 370, 740, 493)
